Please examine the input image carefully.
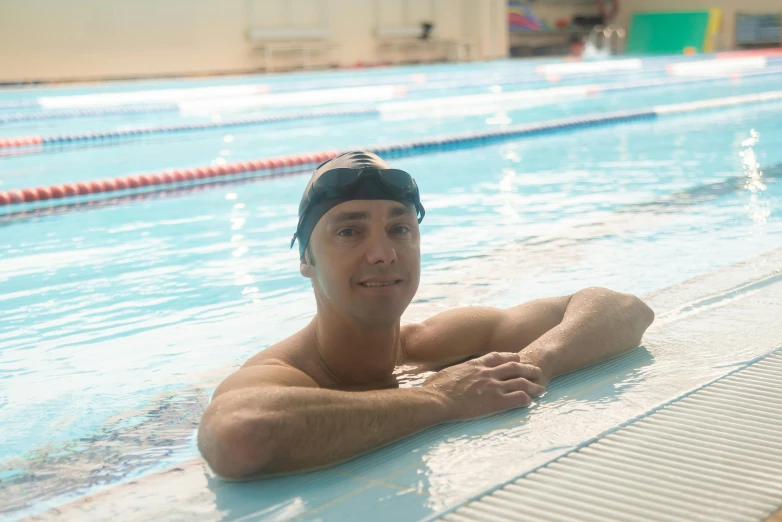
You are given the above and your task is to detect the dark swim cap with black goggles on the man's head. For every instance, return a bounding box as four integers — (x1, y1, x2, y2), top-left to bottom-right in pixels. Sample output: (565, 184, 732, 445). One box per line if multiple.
(291, 151, 424, 258)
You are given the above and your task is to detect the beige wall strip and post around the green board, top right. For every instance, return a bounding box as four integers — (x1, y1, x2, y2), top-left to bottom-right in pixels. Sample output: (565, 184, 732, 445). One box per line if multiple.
(616, 0, 782, 51)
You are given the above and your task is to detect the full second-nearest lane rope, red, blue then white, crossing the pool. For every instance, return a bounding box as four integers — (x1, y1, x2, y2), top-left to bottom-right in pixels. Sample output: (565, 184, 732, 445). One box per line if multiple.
(7, 67, 782, 156)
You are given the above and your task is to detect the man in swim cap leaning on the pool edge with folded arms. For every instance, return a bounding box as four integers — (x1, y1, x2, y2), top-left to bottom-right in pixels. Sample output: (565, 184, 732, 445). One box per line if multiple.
(198, 152, 654, 479)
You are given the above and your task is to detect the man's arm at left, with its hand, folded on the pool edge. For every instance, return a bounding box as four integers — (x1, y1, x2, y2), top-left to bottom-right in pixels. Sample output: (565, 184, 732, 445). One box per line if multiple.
(198, 353, 543, 479)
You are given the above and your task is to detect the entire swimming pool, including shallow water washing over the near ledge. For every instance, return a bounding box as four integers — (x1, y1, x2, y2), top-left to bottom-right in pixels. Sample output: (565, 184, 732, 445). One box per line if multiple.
(0, 54, 782, 520)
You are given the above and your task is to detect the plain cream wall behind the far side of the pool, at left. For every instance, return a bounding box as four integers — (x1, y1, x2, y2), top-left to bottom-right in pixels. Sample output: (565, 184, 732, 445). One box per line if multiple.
(0, 0, 508, 82)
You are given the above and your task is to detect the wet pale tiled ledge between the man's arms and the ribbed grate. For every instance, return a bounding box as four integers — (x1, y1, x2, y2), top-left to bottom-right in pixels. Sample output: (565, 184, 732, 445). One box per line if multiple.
(31, 249, 782, 522)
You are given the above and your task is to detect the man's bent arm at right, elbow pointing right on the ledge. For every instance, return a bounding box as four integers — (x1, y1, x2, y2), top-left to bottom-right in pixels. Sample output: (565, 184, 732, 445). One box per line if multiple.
(406, 288, 654, 384)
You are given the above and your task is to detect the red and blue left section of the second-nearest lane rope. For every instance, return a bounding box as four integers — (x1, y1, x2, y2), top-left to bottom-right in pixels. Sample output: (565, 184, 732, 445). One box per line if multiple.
(0, 108, 378, 154)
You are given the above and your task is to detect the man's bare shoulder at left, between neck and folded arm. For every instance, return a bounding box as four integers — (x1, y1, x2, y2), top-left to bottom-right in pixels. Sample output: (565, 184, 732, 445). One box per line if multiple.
(213, 330, 319, 398)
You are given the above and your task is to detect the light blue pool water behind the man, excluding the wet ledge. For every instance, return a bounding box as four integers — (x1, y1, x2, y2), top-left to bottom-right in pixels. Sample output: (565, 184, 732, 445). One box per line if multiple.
(0, 58, 782, 512)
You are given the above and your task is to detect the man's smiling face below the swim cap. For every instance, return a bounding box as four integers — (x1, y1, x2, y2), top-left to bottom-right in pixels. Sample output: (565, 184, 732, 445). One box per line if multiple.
(301, 200, 421, 326)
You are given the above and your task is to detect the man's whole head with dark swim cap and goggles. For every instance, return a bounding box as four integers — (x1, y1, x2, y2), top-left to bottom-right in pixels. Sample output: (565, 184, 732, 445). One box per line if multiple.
(294, 148, 424, 325)
